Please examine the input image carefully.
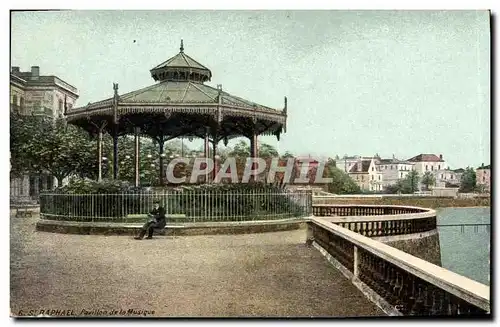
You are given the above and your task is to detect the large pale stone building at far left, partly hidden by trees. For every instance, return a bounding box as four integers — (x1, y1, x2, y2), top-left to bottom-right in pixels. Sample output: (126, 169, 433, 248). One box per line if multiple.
(10, 66, 78, 201)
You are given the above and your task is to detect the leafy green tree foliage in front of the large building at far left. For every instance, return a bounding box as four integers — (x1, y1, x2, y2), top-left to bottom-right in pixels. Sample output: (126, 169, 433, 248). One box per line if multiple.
(11, 113, 96, 185)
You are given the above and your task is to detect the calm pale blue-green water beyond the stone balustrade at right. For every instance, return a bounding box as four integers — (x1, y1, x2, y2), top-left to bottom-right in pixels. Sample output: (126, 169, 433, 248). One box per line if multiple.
(436, 207, 491, 285)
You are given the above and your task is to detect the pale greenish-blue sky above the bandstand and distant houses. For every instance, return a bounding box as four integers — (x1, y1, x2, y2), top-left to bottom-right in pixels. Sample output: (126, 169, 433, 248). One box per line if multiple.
(11, 10, 491, 169)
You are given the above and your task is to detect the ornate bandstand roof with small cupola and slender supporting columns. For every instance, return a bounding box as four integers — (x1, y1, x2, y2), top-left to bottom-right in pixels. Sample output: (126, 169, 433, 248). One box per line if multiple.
(66, 40, 287, 186)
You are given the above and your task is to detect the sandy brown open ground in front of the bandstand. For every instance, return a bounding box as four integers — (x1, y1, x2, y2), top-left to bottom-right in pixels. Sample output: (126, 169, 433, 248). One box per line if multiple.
(11, 217, 383, 317)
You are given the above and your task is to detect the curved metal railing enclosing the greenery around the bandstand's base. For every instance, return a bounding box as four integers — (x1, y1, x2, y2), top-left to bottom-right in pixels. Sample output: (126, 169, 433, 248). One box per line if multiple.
(40, 189, 312, 222)
